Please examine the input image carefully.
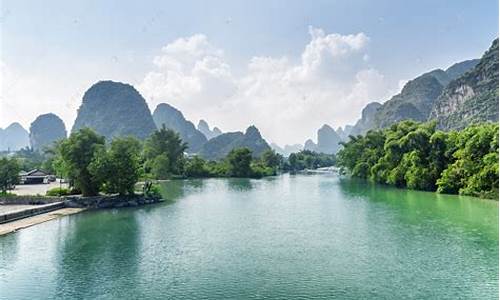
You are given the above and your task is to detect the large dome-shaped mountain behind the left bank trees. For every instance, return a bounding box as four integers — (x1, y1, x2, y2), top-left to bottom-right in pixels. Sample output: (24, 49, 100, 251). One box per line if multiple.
(71, 81, 156, 140)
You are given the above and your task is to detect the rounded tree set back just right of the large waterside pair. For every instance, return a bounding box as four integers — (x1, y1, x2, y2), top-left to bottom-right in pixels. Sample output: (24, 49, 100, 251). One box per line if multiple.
(144, 125, 188, 176)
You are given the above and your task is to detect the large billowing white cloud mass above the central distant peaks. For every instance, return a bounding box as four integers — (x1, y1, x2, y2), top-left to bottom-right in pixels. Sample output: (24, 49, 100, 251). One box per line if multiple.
(138, 27, 393, 144)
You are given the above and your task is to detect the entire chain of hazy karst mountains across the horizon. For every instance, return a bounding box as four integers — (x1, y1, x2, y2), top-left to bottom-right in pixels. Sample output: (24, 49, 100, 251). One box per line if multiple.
(0, 39, 498, 159)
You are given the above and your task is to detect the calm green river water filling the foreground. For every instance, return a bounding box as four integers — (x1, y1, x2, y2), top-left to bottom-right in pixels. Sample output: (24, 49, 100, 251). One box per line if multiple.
(0, 175, 498, 299)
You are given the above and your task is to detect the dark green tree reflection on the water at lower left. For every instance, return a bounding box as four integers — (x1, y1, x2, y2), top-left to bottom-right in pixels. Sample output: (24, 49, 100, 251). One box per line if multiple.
(56, 209, 140, 298)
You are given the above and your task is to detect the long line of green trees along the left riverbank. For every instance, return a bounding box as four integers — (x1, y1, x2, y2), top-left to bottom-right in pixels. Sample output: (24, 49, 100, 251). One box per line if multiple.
(0, 126, 335, 196)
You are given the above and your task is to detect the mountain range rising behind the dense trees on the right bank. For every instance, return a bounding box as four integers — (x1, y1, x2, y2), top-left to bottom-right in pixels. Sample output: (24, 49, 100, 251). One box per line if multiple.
(343, 39, 498, 135)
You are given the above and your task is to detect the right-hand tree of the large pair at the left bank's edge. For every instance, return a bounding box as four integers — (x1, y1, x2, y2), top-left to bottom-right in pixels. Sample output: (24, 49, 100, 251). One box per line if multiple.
(89, 137, 141, 195)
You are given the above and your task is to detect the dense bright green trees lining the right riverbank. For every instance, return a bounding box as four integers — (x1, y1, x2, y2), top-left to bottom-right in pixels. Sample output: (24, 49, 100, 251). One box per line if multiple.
(337, 121, 498, 199)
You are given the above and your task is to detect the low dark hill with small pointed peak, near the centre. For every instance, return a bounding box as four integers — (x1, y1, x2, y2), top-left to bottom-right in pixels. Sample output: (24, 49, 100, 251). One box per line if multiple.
(199, 126, 271, 160)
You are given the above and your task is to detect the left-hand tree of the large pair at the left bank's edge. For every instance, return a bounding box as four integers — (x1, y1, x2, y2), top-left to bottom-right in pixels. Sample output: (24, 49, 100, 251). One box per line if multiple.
(55, 128, 105, 196)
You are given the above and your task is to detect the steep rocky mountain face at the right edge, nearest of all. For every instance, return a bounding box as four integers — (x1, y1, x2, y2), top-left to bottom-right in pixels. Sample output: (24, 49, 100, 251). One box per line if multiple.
(429, 39, 498, 129)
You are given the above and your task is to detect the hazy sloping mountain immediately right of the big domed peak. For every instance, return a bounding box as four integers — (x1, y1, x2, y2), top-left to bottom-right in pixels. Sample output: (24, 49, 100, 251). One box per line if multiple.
(153, 103, 207, 153)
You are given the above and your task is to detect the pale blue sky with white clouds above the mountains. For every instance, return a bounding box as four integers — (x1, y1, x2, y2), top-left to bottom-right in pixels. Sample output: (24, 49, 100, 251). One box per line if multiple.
(0, 0, 498, 145)
